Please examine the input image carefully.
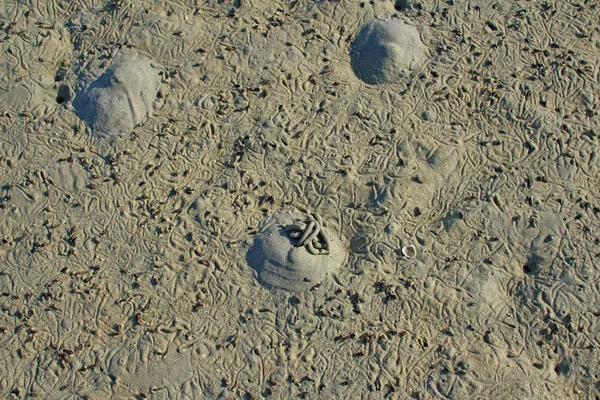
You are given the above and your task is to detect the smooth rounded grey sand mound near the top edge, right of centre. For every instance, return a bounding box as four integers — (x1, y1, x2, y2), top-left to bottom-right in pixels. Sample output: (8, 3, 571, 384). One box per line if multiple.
(350, 19, 428, 84)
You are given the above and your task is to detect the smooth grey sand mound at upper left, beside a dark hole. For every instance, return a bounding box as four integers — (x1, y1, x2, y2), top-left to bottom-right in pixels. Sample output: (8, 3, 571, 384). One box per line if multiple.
(73, 59, 160, 136)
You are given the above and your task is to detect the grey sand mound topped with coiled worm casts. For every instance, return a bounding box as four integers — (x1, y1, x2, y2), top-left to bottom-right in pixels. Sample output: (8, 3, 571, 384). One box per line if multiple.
(246, 211, 346, 291)
